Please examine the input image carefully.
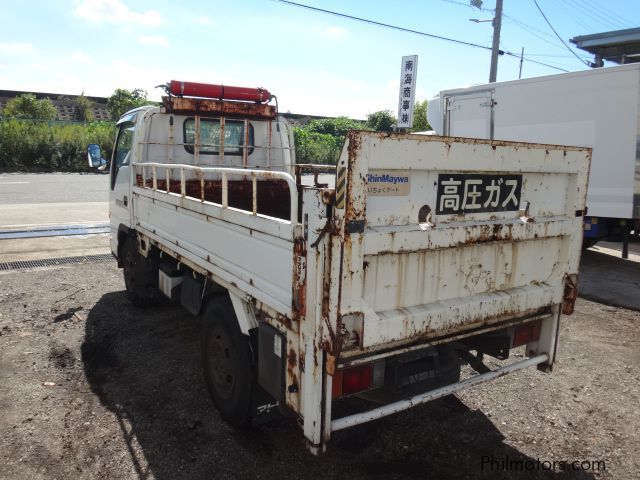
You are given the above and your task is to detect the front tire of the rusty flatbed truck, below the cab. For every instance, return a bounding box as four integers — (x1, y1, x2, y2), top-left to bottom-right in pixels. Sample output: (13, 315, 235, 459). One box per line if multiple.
(122, 238, 160, 308)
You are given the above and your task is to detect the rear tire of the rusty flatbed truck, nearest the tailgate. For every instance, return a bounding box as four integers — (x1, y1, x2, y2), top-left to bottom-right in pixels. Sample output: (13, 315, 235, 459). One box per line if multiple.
(201, 298, 254, 427)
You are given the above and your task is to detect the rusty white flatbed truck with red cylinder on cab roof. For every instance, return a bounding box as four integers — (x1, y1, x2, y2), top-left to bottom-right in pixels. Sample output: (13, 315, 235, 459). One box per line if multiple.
(88, 81, 591, 452)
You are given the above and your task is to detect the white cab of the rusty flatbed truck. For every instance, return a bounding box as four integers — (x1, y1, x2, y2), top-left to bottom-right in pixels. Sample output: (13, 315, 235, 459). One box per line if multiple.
(104, 82, 295, 255)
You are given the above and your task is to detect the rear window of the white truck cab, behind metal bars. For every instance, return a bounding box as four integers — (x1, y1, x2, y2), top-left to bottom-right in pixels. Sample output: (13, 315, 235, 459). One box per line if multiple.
(184, 118, 254, 155)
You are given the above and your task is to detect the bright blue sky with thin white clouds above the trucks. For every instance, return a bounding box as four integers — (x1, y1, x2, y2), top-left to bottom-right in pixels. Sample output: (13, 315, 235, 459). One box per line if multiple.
(0, 0, 640, 119)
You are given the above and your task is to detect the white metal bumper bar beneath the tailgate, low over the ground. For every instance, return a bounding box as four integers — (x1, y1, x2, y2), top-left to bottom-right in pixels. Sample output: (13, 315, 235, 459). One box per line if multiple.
(331, 353, 549, 432)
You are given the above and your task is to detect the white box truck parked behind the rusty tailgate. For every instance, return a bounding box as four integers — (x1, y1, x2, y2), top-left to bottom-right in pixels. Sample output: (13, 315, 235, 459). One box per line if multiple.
(428, 63, 640, 258)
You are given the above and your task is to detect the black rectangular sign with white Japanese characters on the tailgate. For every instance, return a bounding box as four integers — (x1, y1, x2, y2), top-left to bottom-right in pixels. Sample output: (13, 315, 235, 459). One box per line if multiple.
(436, 173, 522, 215)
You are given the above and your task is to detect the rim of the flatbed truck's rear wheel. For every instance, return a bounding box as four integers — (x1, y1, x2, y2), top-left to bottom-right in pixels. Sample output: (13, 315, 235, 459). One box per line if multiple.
(207, 326, 236, 400)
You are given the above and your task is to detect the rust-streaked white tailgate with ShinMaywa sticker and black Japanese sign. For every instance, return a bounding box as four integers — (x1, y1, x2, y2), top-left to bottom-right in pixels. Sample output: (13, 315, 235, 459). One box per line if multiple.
(330, 132, 591, 355)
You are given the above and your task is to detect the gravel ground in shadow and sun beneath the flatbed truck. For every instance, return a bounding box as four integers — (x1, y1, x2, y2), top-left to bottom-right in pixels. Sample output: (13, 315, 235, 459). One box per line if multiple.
(0, 262, 640, 480)
